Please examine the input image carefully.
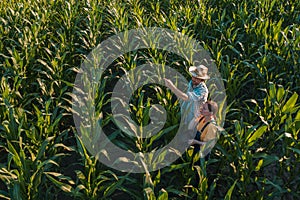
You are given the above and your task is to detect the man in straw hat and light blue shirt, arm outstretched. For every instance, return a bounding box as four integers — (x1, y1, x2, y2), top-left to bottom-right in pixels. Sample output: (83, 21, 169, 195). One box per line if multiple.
(165, 65, 210, 123)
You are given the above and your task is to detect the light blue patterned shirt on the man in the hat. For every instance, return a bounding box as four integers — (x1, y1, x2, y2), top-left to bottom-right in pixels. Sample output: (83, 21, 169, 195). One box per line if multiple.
(181, 81, 208, 123)
